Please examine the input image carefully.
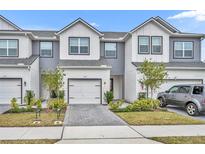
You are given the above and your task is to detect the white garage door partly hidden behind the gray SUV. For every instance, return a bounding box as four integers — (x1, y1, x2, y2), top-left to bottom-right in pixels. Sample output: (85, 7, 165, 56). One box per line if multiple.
(154, 79, 202, 96)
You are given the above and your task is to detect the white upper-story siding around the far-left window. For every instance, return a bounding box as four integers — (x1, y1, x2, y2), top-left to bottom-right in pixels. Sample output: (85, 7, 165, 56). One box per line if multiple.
(0, 34, 32, 58)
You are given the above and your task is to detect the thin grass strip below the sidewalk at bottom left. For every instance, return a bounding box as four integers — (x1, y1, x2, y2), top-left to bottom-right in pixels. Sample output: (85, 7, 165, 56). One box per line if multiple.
(0, 139, 59, 144)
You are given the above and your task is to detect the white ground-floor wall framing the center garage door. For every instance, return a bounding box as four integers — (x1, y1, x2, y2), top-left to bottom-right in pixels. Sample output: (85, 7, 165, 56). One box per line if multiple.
(63, 69, 110, 103)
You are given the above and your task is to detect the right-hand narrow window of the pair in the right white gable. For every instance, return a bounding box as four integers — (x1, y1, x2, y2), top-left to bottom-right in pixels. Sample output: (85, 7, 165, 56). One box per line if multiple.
(151, 36, 162, 54)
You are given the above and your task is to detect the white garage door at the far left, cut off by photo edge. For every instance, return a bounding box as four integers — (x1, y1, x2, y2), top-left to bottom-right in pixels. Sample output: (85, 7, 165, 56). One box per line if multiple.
(0, 79, 21, 104)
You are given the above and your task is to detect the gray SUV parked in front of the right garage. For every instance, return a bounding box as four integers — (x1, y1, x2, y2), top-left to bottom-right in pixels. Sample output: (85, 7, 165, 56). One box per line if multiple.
(157, 84, 205, 116)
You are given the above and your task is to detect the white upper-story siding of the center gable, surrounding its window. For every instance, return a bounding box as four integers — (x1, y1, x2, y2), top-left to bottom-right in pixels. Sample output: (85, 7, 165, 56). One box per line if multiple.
(60, 23, 100, 60)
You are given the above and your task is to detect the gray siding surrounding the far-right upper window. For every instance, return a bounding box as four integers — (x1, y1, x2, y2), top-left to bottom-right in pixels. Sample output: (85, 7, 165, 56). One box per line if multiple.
(169, 37, 201, 62)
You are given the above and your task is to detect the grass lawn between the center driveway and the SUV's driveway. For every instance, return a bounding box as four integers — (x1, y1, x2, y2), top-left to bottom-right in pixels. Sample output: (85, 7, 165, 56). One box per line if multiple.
(116, 111, 205, 125)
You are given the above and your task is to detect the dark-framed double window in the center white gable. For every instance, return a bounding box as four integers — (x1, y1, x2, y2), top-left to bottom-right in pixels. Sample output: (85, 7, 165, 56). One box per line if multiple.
(69, 37, 90, 55)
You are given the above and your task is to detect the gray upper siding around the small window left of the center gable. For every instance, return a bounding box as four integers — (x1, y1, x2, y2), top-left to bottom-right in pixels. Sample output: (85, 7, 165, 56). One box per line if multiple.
(32, 41, 59, 71)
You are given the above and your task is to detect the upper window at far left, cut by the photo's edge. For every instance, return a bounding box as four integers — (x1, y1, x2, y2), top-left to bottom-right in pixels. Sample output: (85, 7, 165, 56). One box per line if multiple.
(0, 40, 18, 57)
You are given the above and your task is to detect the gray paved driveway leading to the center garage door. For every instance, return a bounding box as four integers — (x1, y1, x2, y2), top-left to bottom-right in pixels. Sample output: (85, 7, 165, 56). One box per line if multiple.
(64, 104, 127, 126)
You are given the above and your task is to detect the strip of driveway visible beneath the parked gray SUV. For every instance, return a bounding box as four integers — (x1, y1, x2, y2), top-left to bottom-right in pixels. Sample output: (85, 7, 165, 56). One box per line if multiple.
(167, 105, 205, 120)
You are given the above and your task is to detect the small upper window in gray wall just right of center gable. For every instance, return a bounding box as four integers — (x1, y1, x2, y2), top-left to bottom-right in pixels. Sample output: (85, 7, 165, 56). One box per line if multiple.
(105, 43, 117, 58)
